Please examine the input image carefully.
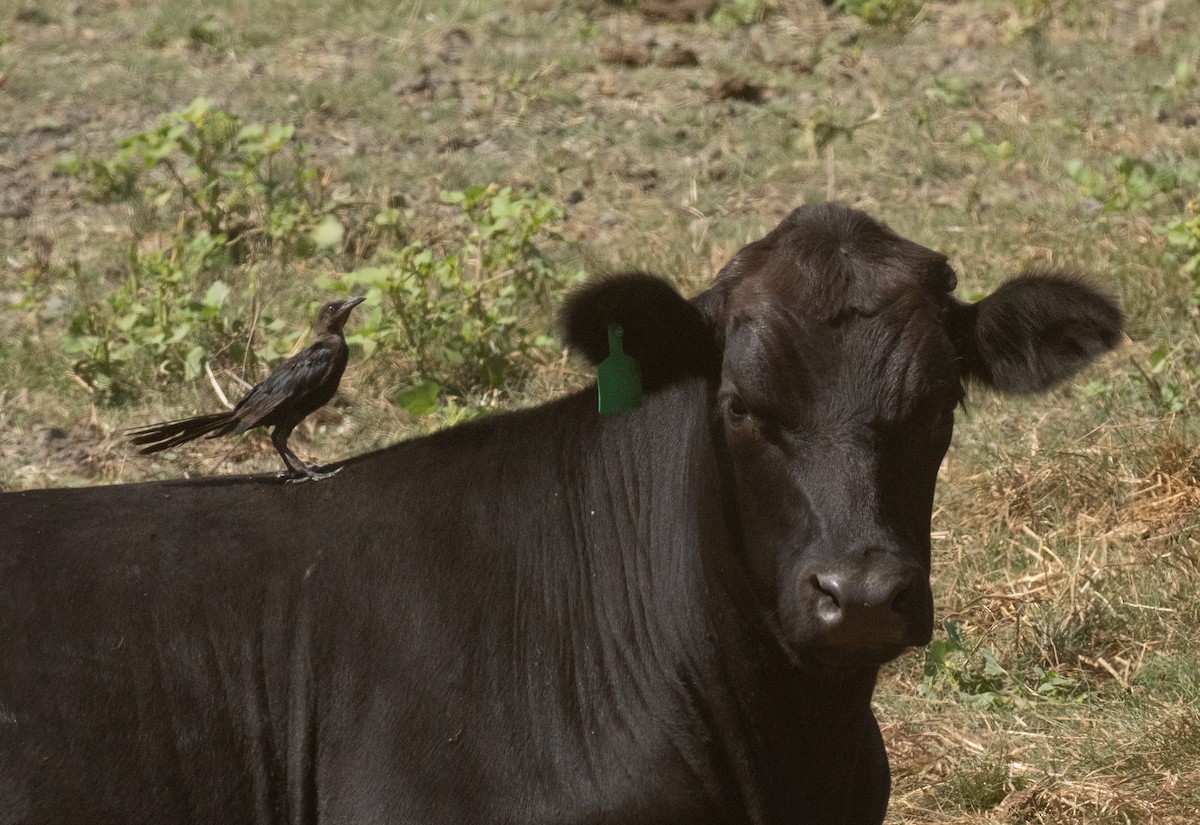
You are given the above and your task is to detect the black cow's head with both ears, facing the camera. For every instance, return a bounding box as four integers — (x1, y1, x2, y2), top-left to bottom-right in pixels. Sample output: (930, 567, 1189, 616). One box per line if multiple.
(563, 205, 1121, 664)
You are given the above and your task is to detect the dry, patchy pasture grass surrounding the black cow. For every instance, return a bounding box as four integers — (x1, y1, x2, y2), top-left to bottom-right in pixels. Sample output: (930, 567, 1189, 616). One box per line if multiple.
(0, 0, 1200, 825)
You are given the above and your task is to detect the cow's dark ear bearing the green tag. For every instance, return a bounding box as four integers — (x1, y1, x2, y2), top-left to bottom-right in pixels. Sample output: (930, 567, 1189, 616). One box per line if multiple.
(559, 272, 720, 390)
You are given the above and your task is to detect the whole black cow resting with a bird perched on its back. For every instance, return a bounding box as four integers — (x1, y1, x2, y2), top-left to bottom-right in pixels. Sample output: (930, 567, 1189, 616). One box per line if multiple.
(0, 206, 1121, 825)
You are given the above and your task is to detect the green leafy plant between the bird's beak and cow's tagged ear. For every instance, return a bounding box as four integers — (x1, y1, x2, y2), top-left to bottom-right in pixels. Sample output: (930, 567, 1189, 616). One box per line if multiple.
(320, 185, 583, 415)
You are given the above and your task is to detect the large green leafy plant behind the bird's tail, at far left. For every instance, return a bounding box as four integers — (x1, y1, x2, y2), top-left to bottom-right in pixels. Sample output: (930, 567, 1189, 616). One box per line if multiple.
(50, 98, 403, 401)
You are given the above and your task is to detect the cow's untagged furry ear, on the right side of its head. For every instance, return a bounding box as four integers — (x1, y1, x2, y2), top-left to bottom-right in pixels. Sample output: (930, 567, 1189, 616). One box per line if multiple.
(949, 273, 1122, 393)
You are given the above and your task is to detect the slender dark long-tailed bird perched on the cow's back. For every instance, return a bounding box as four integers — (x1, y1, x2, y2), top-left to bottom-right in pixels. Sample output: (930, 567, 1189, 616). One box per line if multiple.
(128, 297, 364, 480)
